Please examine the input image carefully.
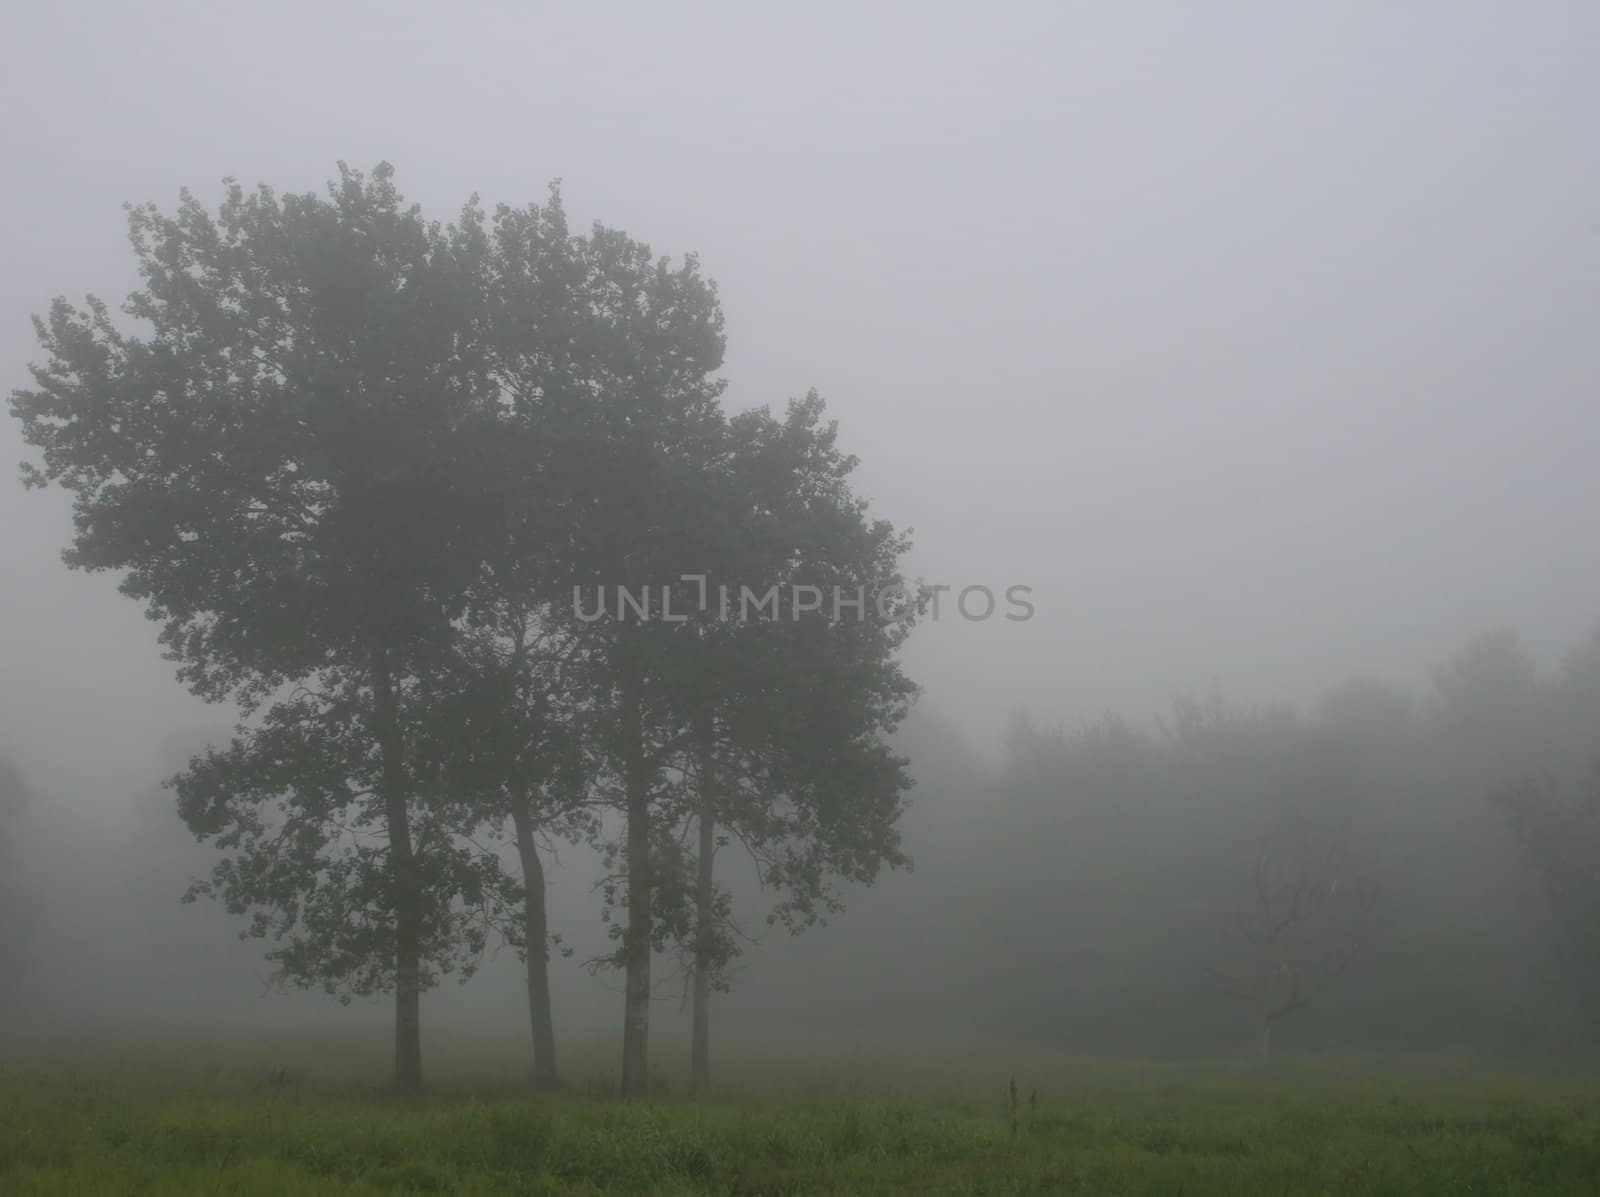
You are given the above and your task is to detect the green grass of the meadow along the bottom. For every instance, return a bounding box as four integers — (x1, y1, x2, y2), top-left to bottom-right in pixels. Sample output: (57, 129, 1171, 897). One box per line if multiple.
(0, 1045, 1600, 1197)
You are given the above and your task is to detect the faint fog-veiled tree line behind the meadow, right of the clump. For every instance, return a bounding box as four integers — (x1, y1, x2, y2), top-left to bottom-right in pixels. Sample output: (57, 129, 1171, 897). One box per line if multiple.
(739, 631, 1600, 1056)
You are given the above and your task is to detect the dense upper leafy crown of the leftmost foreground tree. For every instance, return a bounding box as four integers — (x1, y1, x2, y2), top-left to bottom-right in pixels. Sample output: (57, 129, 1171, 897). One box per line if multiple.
(11, 168, 493, 701)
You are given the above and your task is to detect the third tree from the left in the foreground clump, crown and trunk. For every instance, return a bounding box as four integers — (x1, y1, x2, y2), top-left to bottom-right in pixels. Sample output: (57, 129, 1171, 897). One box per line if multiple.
(473, 195, 726, 1093)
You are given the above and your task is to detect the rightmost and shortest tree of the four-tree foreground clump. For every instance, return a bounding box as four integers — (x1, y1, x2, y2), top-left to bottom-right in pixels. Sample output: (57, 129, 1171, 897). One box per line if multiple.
(677, 392, 922, 1091)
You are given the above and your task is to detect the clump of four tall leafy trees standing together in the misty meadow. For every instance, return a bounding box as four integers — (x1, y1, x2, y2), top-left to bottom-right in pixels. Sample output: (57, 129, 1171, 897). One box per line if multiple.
(11, 165, 922, 1095)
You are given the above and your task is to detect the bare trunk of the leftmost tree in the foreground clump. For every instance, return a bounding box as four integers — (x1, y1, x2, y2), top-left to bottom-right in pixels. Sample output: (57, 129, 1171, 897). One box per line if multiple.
(373, 647, 422, 1093)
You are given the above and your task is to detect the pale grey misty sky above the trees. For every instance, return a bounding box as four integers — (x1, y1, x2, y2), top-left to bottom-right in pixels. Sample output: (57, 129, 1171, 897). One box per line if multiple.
(0, 2, 1600, 792)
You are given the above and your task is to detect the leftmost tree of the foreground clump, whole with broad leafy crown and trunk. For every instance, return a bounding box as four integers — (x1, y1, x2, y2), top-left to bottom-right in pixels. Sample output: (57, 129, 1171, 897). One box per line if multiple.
(11, 165, 506, 1088)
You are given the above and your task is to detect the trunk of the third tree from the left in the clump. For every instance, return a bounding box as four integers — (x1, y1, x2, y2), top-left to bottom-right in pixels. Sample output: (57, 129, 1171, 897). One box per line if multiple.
(621, 663, 654, 1098)
